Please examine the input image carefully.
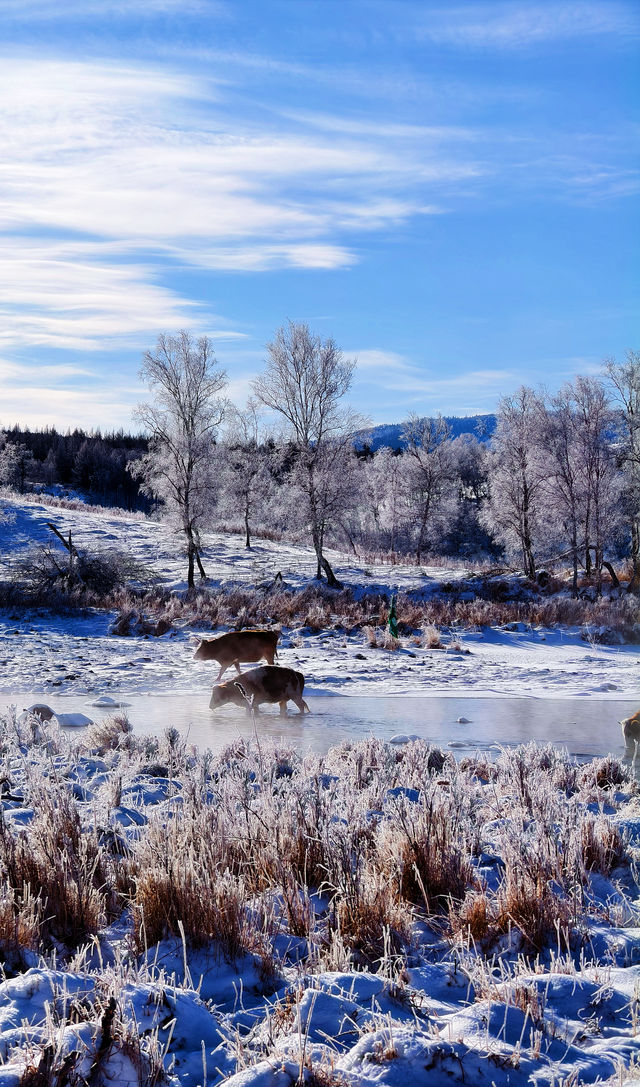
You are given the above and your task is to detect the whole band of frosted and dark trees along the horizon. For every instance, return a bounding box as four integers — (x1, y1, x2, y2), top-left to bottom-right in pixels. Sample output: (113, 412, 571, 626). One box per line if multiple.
(0, 322, 640, 595)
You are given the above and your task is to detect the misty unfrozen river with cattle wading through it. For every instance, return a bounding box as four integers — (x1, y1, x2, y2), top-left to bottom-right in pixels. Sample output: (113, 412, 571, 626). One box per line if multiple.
(9, 692, 638, 759)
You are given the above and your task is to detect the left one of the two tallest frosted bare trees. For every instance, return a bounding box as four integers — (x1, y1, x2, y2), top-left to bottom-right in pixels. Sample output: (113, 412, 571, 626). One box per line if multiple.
(130, 330, 227, 588)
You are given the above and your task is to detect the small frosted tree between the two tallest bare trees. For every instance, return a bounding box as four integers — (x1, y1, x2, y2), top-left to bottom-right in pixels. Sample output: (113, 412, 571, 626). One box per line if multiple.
(221, 399, 276, 548)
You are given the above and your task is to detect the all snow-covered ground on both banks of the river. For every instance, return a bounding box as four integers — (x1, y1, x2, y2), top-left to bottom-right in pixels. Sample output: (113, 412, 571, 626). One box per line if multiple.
(0, 501, 640, 1087)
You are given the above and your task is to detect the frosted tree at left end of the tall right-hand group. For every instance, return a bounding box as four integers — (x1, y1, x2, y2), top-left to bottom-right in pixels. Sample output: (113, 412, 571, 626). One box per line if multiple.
(486, 385, 548, 578)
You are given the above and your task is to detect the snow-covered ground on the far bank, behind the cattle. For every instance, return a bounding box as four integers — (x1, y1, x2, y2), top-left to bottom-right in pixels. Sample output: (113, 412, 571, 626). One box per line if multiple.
(0, 500, 640, 700)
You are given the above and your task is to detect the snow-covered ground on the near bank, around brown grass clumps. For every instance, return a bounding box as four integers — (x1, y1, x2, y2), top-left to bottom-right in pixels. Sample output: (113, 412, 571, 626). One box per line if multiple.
(0, 720, 640, 1087)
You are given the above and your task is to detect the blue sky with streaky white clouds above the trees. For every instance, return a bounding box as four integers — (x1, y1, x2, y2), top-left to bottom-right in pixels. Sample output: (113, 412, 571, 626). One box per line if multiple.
(0, 0, 640, 432)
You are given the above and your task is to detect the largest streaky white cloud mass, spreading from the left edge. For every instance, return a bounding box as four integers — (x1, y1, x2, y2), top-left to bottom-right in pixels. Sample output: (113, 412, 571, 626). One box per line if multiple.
(0, 58, 474, 350)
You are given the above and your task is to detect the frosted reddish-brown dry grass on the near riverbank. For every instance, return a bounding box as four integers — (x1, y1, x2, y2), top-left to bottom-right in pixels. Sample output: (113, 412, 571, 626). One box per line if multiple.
(0, 716, 633, 976)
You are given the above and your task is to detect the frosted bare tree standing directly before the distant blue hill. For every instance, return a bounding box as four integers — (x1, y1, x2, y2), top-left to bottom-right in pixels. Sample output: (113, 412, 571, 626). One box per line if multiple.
(402, 415, 455, 563)
